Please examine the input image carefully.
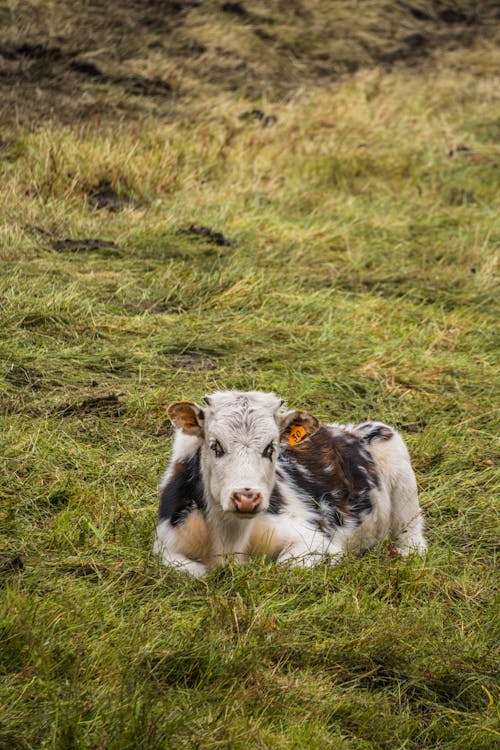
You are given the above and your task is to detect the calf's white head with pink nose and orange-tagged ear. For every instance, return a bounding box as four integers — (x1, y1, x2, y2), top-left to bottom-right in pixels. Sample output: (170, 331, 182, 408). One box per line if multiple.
(168, 391, 319, 518)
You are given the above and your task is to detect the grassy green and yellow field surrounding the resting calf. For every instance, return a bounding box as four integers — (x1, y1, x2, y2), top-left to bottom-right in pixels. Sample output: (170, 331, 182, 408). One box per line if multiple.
(0, 0, 500, 750)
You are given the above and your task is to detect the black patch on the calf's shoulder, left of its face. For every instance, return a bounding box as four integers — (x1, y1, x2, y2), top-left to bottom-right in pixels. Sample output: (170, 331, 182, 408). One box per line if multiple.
(159, 450, 205, 526)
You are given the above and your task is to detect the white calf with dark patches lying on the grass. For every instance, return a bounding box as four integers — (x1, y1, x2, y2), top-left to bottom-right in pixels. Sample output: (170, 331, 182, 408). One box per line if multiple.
(154, 391, 426, 576)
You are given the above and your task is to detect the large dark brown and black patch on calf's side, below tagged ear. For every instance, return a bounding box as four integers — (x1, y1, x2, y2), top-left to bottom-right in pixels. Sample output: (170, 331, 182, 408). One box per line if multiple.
(283, 425, 379, 526)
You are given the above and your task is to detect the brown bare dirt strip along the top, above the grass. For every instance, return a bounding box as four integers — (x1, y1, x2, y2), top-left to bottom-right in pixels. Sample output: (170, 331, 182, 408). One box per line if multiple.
(0, 0, 500, 129)
